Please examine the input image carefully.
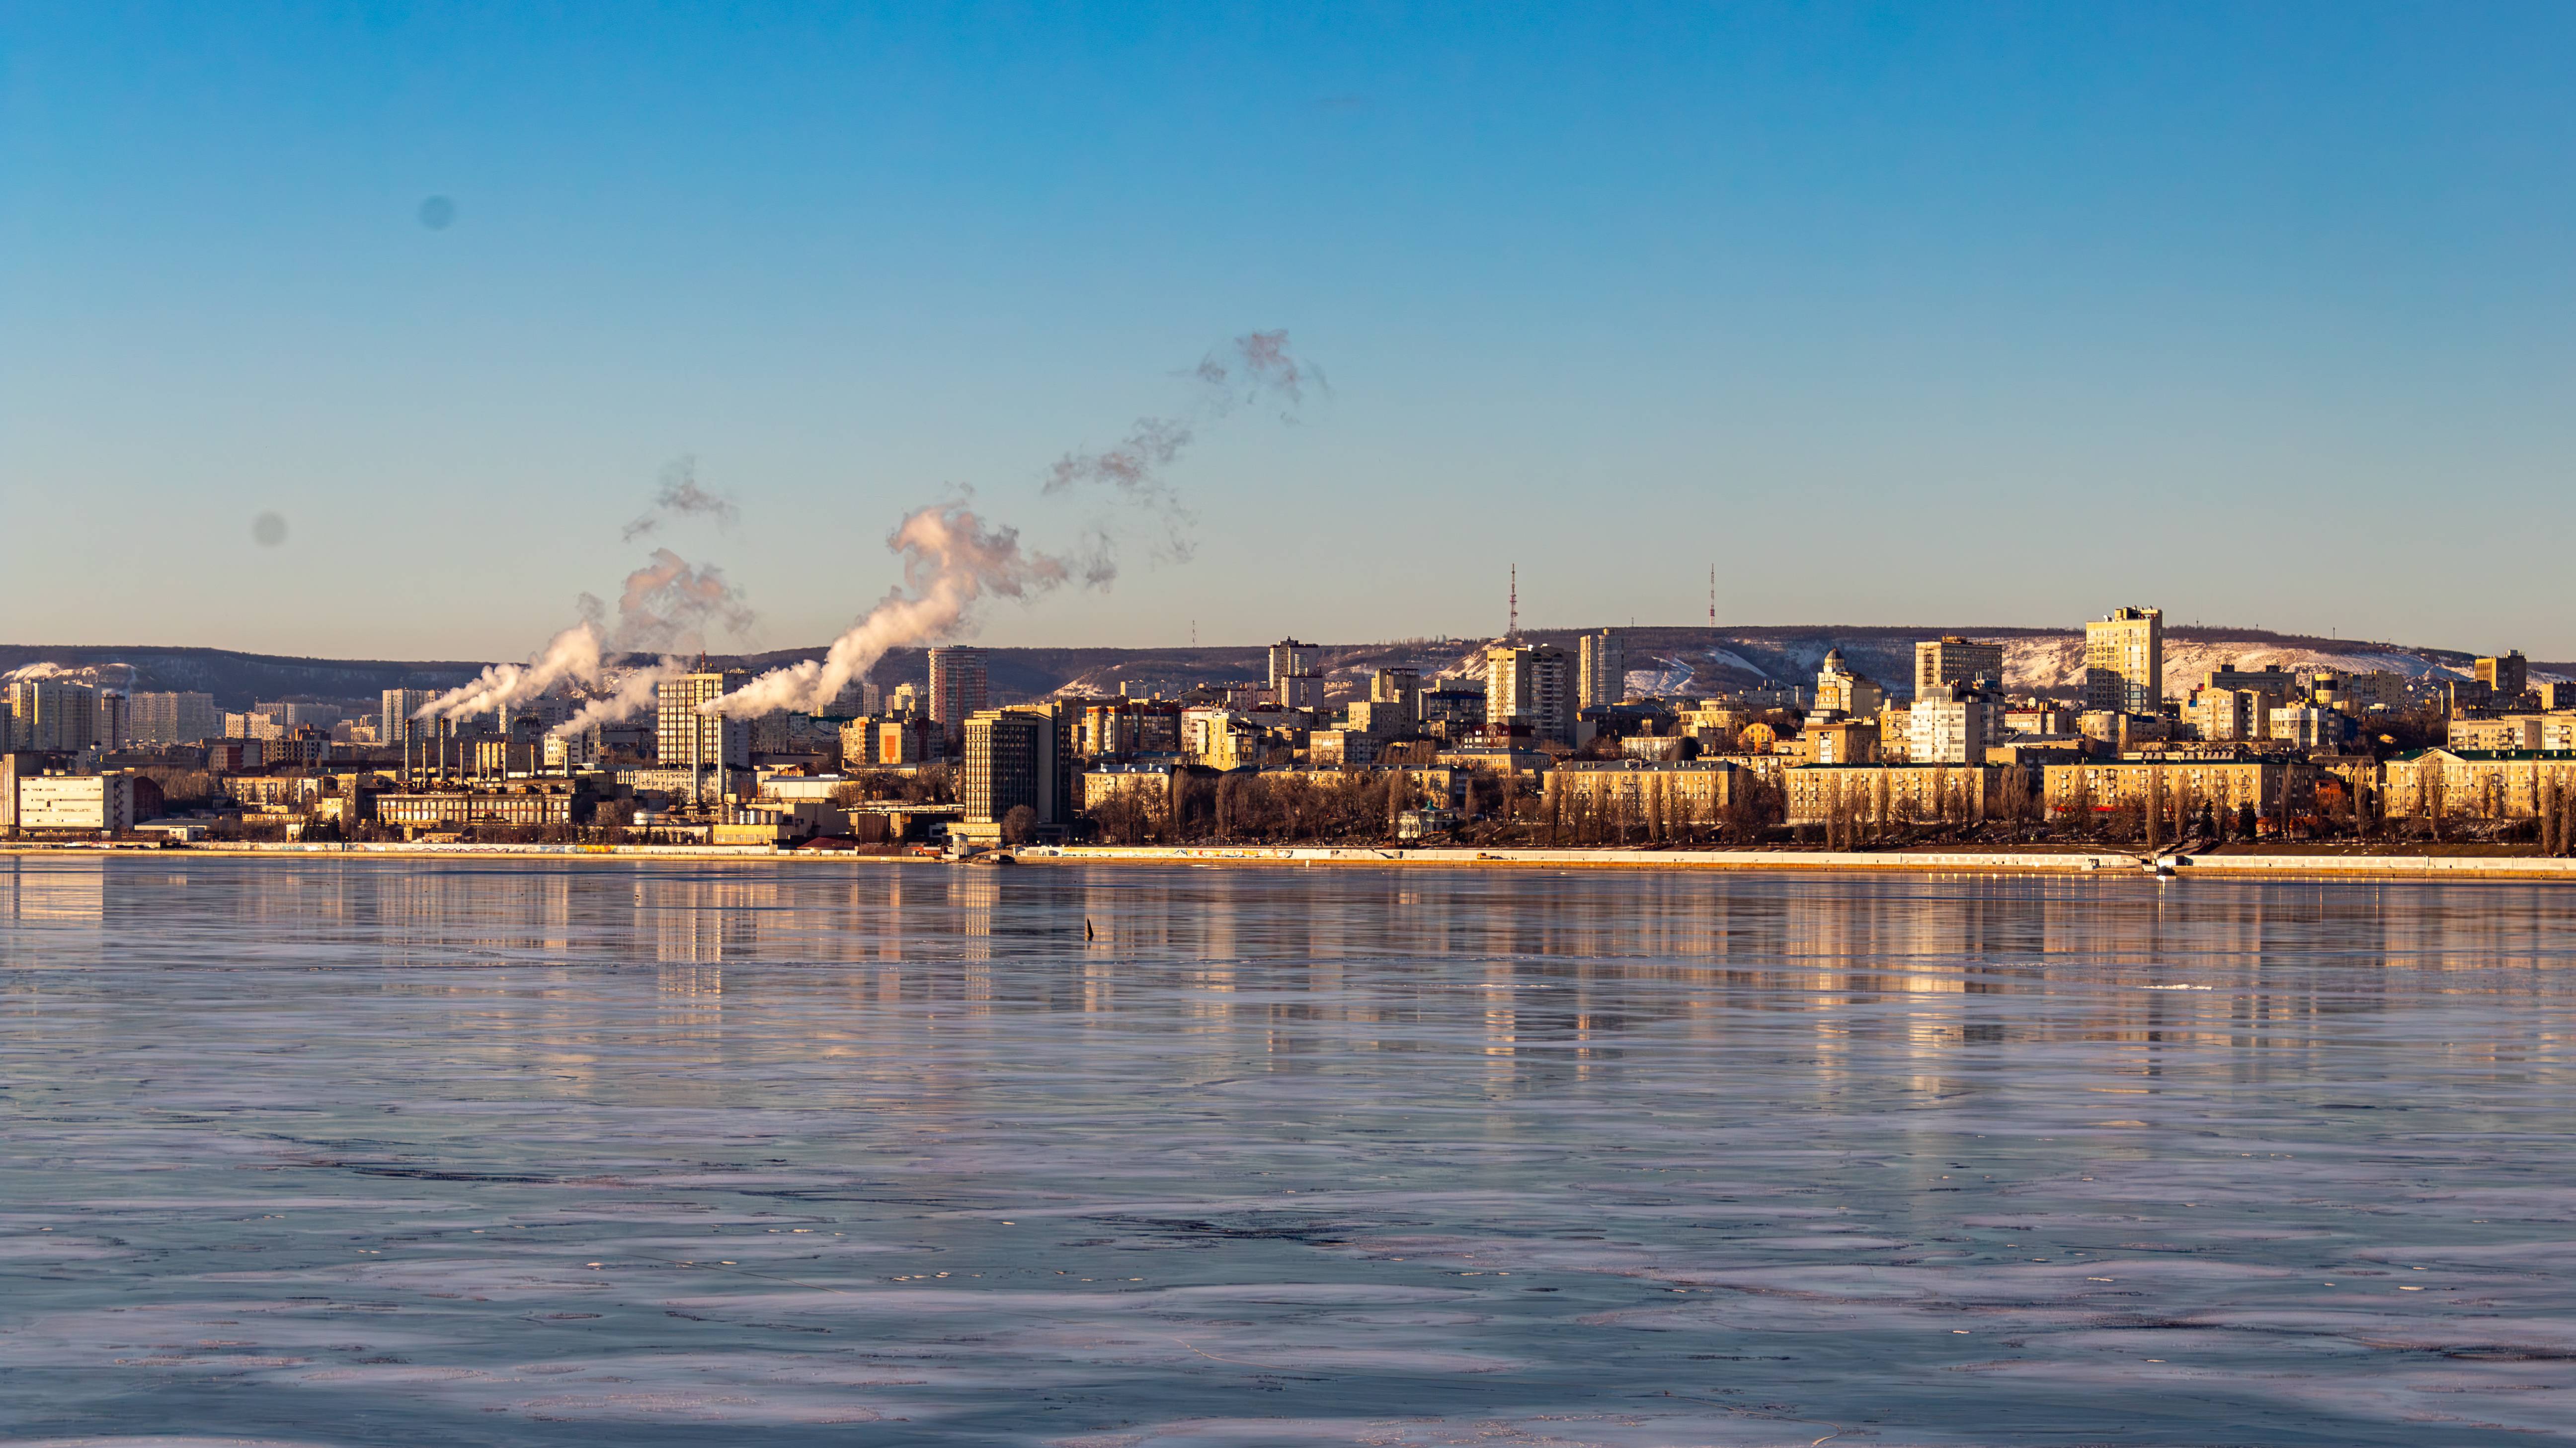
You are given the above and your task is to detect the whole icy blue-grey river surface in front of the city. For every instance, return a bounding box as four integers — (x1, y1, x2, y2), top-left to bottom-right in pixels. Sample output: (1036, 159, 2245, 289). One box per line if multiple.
(0, 858, 2576, 1446)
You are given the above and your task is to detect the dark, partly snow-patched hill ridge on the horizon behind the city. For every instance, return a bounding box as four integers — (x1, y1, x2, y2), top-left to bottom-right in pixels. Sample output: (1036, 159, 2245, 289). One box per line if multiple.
(0, 623, 2535, 708)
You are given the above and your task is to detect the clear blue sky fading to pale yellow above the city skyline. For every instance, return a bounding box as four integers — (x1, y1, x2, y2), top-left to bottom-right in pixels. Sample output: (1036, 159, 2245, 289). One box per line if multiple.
(0, 2, 2576, 660)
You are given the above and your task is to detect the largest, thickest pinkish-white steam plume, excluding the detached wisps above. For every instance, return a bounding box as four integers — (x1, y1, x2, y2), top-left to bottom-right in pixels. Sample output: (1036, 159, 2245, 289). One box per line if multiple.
(714, 503, 1082, 716)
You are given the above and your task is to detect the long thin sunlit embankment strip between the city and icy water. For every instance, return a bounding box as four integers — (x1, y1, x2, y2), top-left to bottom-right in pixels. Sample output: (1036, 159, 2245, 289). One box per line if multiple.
(0, 843, 2576, 881)
